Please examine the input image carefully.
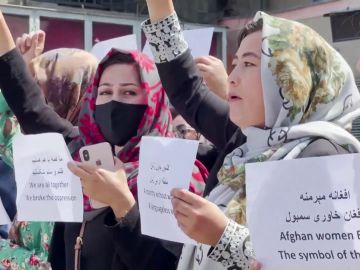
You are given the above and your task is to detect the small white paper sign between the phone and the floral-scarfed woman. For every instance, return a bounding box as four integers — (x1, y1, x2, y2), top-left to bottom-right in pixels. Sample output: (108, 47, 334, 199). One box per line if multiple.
(138, 137, 199, 244)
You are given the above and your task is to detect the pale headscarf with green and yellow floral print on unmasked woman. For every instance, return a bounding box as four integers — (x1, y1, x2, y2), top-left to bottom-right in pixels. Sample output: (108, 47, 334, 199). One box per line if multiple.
(218, 12, 360, 224)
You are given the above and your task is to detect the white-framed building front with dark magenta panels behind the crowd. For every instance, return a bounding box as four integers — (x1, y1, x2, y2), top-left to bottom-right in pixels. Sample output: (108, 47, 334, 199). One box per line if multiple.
(0, 0, 227, 61)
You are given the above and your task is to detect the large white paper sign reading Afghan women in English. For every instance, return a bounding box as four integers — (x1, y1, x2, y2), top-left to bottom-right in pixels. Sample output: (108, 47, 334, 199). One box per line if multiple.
(246, 154, 360, 270)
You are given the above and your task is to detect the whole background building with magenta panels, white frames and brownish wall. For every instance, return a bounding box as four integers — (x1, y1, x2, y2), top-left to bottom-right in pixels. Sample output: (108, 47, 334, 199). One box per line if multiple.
(0, 0, 360, 138)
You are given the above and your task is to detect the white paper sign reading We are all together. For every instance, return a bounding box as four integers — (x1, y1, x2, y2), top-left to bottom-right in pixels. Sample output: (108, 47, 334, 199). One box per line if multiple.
(13, 133, 83, 222)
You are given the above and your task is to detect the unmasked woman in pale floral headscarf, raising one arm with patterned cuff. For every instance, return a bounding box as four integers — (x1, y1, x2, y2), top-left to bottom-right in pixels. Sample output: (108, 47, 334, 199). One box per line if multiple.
(143, 0, 360, 269)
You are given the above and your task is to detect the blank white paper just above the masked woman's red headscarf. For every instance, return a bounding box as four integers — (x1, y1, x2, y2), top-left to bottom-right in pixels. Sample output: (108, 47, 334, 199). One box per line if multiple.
(90, 35, 137, 61)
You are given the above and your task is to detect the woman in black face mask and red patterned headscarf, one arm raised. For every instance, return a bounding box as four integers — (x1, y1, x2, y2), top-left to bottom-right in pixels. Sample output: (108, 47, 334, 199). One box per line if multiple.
(0, 11, 203, 270)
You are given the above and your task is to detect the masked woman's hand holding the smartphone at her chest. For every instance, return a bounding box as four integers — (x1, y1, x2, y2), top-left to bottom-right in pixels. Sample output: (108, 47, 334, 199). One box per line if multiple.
(68, 158, 135, 218)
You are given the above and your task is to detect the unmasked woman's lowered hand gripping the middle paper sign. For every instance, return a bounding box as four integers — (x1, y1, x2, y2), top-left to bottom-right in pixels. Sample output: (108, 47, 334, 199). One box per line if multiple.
(171, 189, 228, 246)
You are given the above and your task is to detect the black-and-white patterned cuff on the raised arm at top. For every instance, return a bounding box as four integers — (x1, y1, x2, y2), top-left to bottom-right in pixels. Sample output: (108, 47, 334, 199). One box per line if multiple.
(142, 13, 188, 63)
